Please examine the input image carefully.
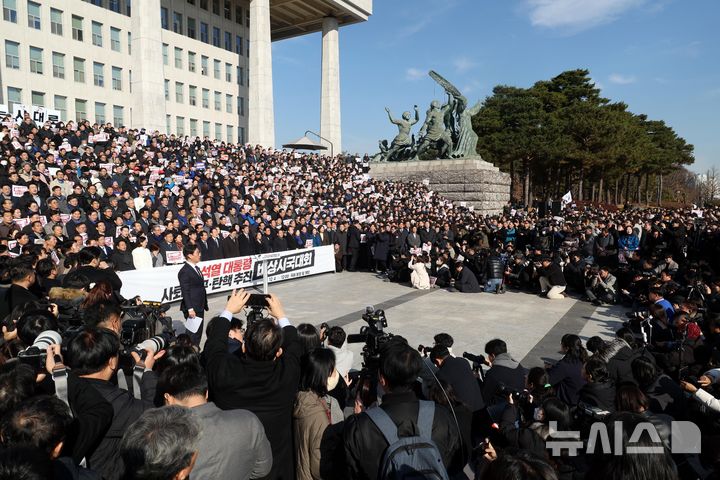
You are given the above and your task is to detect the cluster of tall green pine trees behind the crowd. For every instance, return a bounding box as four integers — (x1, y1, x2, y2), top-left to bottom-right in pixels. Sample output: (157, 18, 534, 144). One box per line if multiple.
(473, 69, 694, 205)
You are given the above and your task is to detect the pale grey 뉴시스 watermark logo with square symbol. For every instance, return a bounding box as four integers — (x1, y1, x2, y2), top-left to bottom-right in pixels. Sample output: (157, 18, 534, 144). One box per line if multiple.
(546, 421, 701, 457)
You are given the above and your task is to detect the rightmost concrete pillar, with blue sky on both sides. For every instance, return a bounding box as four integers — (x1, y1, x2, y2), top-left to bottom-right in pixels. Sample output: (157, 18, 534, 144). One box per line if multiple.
(320, 17, 342, 155)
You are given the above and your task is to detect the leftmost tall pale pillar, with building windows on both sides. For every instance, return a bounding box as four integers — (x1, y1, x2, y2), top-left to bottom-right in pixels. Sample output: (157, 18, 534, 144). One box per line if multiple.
(125, 0, 169, 133)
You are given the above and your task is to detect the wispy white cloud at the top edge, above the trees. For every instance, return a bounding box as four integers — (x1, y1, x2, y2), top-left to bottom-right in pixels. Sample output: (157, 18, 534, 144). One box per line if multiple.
(526, 0, 647, 31)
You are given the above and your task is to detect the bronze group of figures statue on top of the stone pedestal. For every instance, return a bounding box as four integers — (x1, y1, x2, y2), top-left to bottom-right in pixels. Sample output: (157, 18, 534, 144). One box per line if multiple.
(373, 70, 482, 162)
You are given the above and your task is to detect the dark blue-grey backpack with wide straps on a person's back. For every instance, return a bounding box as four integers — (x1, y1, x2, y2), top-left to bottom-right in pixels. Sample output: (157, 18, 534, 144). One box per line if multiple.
(366, 400, 448, 480)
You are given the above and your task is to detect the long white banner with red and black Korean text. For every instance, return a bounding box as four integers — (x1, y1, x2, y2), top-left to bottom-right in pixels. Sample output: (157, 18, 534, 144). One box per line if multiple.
(118, 245, 335, 302)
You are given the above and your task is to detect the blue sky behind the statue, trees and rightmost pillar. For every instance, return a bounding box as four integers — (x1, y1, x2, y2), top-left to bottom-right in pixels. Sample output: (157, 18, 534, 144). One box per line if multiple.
(273, 0, 720, 172)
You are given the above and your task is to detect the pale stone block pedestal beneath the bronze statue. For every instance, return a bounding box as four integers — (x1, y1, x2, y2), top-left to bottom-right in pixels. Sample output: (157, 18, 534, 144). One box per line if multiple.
(370, 155, 510, 215)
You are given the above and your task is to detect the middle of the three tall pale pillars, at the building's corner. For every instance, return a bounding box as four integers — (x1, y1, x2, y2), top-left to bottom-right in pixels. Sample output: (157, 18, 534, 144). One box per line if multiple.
(248, 0, 275, 147)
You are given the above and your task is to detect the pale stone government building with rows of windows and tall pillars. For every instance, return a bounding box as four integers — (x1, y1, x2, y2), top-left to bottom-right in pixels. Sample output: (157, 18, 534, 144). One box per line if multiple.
(0, 0, 372, 152)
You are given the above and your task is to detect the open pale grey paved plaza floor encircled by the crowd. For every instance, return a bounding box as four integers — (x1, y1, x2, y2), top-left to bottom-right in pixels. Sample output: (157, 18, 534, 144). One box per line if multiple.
(169, 272, 624, 368)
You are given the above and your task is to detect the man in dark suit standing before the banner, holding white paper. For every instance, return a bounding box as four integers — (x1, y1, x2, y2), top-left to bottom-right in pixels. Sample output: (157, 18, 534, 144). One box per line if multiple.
(178, 245, 208, 346)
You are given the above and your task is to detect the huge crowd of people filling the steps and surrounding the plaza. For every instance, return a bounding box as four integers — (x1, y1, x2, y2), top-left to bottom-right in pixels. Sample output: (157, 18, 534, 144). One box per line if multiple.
(0, 117, 720, 480)
